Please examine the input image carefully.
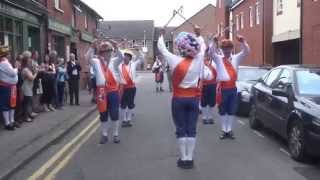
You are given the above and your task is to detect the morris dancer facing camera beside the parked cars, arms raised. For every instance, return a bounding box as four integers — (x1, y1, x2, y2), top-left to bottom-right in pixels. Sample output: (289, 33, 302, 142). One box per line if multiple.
(211, 36, 250, 139)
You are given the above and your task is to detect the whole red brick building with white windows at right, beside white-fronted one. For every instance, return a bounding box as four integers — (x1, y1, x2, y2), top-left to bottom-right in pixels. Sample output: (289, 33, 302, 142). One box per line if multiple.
(231, 0, 273, 65)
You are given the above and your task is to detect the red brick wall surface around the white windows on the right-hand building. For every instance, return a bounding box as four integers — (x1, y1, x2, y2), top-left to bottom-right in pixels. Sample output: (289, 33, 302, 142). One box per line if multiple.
(232, 0, 272, 65)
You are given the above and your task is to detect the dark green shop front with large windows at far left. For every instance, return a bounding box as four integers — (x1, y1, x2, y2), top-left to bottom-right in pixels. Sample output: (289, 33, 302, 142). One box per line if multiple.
(0, 2, 45, 58)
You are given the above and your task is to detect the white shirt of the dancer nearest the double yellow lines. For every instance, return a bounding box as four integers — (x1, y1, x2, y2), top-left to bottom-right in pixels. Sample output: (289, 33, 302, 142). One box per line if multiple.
(85, 48, 123, 86)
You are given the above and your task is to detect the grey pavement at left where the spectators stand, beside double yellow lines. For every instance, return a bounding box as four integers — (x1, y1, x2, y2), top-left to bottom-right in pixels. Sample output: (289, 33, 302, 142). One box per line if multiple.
(0, 91, 95, 179)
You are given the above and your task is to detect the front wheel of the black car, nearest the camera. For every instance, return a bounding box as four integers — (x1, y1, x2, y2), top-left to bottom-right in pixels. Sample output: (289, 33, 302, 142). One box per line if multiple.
(288, 121, 306, 161)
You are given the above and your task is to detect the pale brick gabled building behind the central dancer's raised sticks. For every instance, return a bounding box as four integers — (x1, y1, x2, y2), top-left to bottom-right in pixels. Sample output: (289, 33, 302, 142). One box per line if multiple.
(173, 4, 217, 52)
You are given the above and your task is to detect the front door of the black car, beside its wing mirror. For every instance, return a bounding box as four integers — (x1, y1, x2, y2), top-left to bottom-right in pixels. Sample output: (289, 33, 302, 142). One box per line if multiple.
(268, 69, 293, 134)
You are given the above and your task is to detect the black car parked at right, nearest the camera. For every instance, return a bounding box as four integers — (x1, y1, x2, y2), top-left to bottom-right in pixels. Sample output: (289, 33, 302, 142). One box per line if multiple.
(249, 65, 320, 161)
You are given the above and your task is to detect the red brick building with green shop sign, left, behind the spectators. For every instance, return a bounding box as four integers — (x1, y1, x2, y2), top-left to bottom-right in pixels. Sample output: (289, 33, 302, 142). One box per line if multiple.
(47, 0, 102, 87)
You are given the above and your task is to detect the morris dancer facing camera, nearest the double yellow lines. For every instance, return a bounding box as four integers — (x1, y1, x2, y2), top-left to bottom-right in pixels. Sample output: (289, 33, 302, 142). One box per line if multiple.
(86, 41, 123, 144)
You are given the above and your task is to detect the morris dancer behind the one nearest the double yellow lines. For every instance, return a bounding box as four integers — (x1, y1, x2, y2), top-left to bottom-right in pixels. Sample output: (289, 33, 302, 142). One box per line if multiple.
(119, 49, 143, 127)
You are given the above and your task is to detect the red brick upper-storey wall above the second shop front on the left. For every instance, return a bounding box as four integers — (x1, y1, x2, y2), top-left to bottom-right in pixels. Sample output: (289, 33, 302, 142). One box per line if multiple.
(47, 0, 73, 25)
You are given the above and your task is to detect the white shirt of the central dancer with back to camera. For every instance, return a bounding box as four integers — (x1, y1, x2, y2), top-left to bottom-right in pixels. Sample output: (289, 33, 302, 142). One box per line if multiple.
(158, 35, 206, 88)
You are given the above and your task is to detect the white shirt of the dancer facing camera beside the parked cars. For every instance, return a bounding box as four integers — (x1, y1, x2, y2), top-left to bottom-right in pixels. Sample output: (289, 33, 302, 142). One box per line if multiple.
(210, 42, 250, 81)
